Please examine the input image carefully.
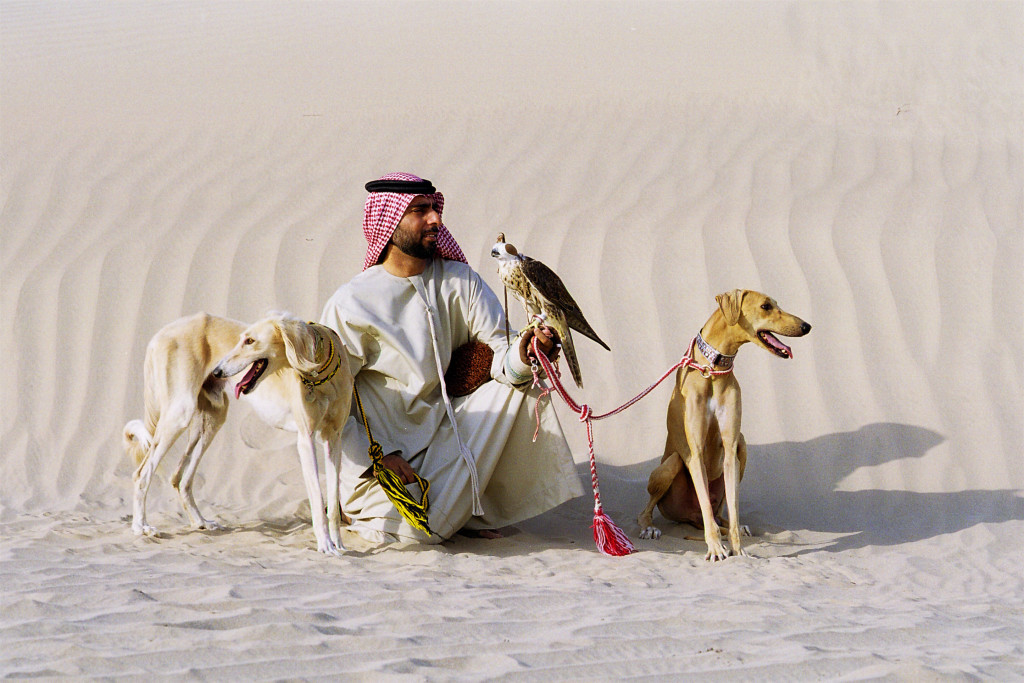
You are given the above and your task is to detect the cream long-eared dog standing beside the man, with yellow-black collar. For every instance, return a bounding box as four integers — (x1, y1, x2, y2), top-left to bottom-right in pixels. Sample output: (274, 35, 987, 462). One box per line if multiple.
(124, 313, 352, 554)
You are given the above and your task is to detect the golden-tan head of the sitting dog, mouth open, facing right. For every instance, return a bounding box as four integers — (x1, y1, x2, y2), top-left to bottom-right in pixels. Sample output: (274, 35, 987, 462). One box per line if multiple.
(715, 290, 811, 358)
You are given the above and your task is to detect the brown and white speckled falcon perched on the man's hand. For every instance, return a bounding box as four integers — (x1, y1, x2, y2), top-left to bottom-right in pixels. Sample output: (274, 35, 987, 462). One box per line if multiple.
(490, 233, 611, 389)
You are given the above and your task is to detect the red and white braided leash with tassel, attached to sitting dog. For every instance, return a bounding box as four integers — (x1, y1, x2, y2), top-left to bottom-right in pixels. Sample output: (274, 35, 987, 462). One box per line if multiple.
(530, 336, 732, 556)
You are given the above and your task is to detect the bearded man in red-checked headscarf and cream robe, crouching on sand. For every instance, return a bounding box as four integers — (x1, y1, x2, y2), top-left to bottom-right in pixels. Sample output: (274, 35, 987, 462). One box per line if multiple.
(322, 173, 583, 543)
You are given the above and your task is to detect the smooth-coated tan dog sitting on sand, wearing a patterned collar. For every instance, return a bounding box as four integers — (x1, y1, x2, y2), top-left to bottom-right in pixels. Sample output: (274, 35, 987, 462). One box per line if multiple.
(637, 290, 811, 561)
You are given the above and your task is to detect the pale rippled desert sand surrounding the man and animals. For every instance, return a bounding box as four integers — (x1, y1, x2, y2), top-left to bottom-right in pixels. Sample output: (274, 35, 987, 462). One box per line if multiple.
(0, 0, 1024, 680)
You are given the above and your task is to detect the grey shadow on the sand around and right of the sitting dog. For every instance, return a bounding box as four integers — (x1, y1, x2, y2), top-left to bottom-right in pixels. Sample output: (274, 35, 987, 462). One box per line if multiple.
(579, 423, 1024, 555)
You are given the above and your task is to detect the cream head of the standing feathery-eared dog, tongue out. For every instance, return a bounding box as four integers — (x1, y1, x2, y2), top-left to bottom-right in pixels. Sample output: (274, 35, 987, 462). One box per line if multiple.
(213, 313, 316, 398)
